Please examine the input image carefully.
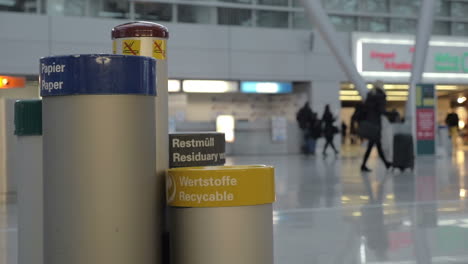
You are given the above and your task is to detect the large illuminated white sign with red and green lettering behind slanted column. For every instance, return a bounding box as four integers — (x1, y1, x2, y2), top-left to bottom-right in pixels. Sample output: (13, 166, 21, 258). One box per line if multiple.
(353, 33, 468, 83)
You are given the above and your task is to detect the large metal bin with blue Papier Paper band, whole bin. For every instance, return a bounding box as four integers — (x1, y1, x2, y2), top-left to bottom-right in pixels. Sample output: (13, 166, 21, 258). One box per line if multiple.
(40, 54, 157, 264)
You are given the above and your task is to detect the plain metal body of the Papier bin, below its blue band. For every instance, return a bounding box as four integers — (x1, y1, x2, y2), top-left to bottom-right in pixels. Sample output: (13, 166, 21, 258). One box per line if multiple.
(43, 95, 155, 264)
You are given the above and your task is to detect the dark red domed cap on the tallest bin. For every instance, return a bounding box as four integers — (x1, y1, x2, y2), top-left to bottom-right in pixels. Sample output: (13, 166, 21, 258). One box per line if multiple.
(112, 21, 169, 39)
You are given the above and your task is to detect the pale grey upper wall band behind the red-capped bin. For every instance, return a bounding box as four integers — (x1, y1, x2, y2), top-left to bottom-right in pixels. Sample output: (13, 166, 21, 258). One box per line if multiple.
(0, 13, 350, 81)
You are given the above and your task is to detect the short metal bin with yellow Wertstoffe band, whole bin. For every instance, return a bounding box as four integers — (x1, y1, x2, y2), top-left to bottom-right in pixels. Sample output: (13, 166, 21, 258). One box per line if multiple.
(166, 165, 275, 264)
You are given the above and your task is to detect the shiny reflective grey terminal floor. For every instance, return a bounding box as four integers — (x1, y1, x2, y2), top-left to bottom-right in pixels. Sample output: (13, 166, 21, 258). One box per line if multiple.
(0, 148, 468, 264)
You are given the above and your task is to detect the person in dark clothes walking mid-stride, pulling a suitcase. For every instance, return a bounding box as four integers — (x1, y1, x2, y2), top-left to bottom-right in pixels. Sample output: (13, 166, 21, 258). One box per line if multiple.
(358, 81, 392, 172)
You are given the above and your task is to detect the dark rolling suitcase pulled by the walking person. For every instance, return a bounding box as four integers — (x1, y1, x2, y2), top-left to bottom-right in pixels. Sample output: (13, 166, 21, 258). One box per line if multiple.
(393, 133, 414, 171)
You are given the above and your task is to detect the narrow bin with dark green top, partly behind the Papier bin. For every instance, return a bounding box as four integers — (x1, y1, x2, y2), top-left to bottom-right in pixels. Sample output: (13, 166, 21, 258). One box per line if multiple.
(14, 100, 44, 264)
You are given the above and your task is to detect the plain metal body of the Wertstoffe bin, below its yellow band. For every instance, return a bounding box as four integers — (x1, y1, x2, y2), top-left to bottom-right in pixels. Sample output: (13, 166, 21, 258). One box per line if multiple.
(169, 204, 273, 264)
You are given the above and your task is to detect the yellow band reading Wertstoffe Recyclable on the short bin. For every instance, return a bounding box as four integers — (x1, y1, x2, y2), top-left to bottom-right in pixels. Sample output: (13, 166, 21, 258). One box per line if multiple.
(166, 165, 275, 207)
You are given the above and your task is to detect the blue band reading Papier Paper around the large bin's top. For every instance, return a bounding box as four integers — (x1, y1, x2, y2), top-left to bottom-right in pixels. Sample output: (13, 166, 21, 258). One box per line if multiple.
(39, 54, 156, 96)
